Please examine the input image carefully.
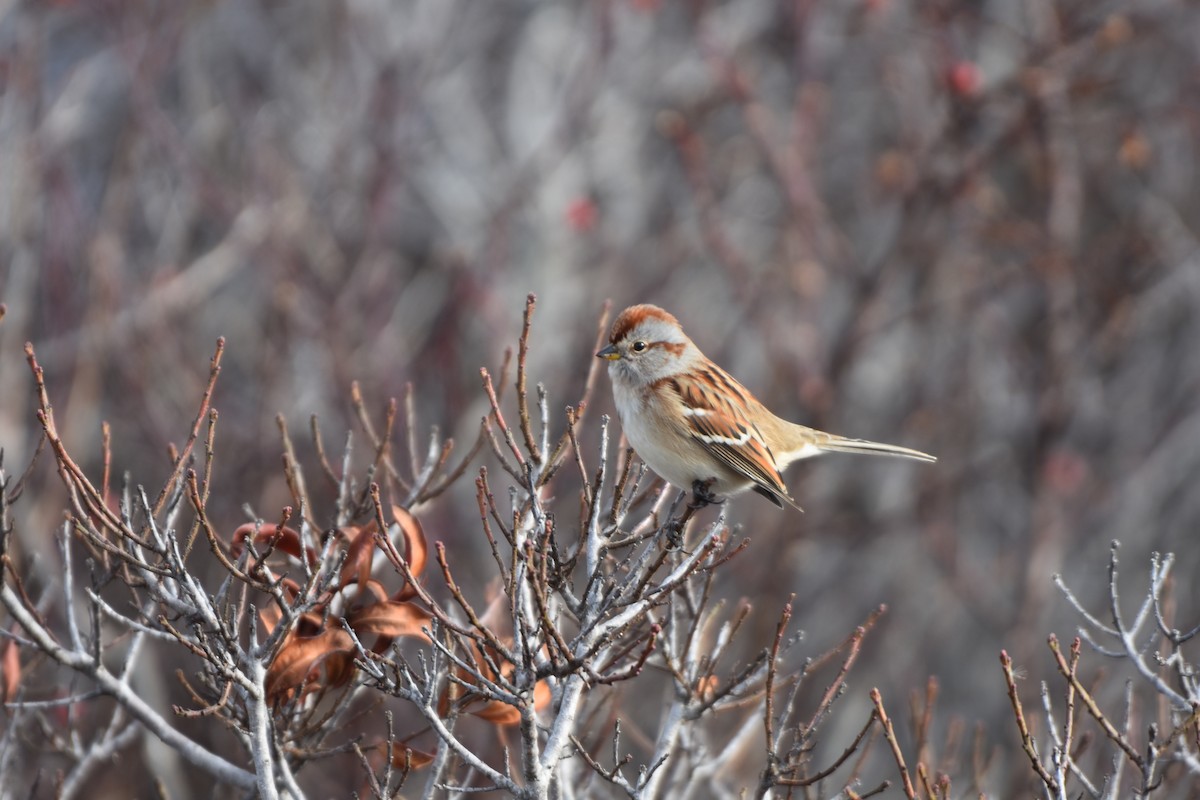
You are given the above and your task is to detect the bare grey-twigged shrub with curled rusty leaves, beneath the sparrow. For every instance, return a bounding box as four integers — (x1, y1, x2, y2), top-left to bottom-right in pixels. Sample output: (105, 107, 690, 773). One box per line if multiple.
(0, 296, 940, 798)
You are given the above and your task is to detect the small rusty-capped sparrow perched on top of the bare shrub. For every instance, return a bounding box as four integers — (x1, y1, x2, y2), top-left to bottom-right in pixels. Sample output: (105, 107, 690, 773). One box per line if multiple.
(596, 305, 937, 509)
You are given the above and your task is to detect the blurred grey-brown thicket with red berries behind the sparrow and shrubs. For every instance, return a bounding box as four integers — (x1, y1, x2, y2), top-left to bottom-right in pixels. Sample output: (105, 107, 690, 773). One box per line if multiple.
(0, 0, 1200, 793)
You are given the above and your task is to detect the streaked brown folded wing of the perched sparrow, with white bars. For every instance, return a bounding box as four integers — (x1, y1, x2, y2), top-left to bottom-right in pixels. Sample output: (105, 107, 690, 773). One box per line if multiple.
(668, 366, 792, 501)
